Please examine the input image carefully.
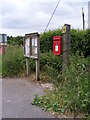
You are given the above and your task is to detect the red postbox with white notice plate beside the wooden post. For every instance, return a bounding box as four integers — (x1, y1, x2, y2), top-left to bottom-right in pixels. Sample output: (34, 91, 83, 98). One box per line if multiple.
(53, 36, 62, 55)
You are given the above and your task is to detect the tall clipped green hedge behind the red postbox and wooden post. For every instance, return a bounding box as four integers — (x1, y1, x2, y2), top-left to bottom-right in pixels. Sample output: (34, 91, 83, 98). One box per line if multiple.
(40, 29, 90, 57)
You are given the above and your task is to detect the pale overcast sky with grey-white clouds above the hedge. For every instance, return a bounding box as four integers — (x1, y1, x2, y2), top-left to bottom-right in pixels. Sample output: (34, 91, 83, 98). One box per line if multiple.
(0, 0, 89, 36)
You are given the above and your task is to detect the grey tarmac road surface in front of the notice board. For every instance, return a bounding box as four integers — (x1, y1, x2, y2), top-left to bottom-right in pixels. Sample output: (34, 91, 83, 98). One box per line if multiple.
(2, 78, 54, 118)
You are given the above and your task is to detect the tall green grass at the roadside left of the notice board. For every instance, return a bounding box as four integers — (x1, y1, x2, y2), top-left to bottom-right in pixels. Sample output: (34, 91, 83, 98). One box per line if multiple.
(2, 46, 25, 77)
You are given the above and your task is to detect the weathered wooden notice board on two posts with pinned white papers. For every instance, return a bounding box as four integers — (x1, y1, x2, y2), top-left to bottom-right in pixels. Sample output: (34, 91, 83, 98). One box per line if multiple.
(24, 32, 40, 80)
